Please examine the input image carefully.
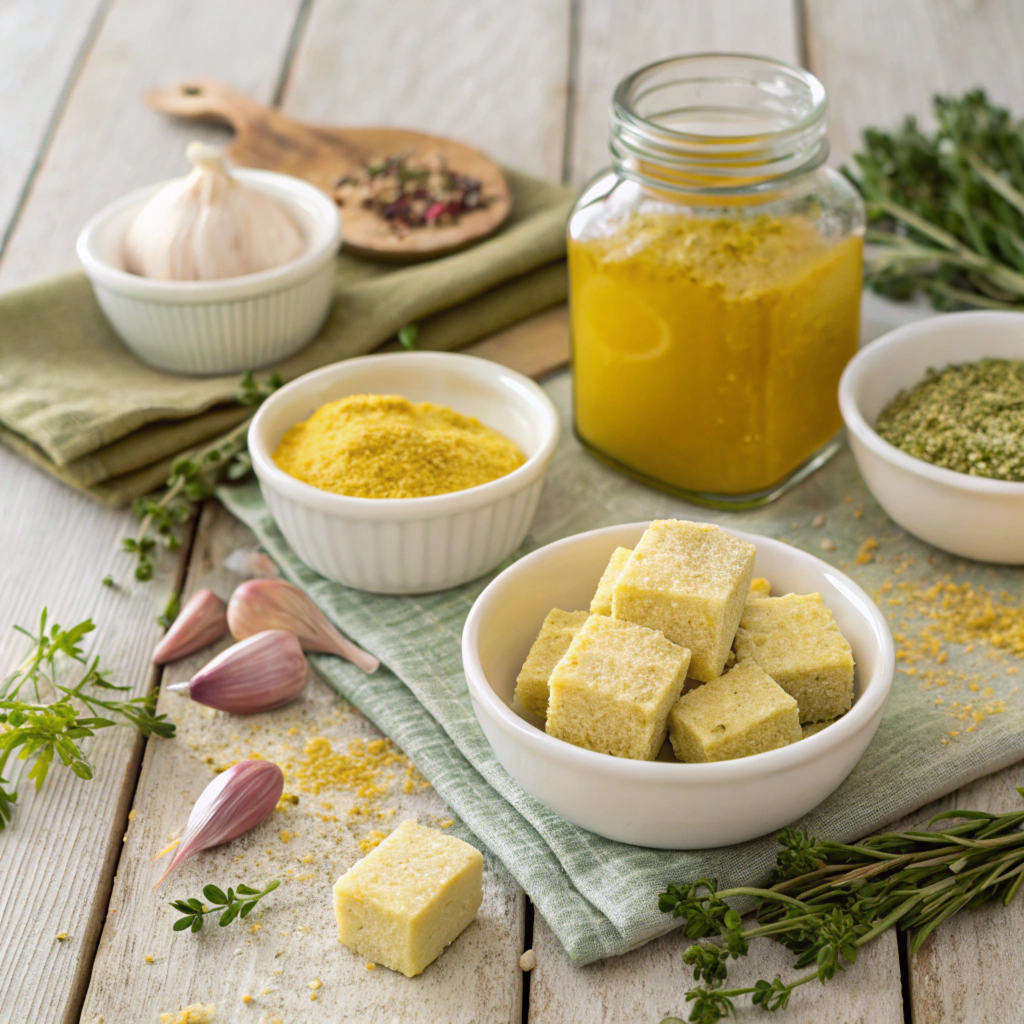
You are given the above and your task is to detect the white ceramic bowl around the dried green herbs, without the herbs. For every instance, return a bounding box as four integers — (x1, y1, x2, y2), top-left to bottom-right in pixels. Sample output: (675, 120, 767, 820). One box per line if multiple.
(839, 312, 1024, 565)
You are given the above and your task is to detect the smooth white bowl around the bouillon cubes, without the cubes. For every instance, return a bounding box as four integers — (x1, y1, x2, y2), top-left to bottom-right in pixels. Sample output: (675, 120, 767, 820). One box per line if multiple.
(462, 522, 895, 850)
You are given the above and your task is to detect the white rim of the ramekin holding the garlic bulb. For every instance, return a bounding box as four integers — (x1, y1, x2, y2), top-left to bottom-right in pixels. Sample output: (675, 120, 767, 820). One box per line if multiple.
(75, 167, 342, 302)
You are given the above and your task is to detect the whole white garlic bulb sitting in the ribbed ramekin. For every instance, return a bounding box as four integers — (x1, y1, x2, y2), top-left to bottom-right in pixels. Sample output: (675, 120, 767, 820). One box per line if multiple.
(124, 142, 305, 281)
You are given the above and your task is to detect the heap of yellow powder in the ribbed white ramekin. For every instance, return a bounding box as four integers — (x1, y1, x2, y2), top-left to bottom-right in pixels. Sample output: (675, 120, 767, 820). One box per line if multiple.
(273, 394, 525, 498)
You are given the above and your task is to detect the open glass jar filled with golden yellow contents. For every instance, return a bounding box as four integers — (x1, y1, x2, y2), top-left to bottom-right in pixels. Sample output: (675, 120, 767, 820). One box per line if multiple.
(568, 54, 864, 507)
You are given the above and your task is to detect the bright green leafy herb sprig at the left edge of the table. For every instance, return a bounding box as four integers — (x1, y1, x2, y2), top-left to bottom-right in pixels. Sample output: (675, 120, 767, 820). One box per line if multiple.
(0, 608, 174, 830)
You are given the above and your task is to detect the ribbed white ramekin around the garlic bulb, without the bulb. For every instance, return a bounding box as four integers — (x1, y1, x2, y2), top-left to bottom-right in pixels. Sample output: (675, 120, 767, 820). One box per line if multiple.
(78, 169, 341, 376)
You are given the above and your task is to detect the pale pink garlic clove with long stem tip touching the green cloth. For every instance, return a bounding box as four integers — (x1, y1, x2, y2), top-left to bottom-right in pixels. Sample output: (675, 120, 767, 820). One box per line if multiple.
(227, 580, 380, 673)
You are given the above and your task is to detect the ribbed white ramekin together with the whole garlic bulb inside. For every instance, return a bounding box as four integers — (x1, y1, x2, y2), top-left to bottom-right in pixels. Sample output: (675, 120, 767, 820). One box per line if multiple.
(78, 143, 341, 375)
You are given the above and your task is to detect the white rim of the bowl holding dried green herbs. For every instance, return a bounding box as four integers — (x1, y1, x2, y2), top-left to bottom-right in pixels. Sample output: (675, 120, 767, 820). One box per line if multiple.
(839, 309, 1024, 499)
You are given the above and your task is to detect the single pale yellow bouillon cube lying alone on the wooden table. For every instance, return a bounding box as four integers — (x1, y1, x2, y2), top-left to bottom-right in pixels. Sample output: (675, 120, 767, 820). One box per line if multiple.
(334, 820, 483, 978)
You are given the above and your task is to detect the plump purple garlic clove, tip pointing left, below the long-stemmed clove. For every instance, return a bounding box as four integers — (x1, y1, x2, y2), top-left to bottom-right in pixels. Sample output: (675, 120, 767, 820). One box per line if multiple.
(166, 630, 309, 715)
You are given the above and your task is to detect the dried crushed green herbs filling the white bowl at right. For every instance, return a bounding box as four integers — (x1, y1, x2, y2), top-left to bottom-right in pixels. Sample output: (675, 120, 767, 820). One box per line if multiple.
(874, 359, 1024, 481)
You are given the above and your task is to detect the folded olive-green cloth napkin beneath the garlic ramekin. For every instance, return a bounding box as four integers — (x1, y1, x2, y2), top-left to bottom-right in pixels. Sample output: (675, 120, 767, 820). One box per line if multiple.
(0, 171, 572, 504)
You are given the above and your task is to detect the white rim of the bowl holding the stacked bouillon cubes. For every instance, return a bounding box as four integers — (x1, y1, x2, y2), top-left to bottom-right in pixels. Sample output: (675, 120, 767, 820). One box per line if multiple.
(462, 520, 896, 784)
